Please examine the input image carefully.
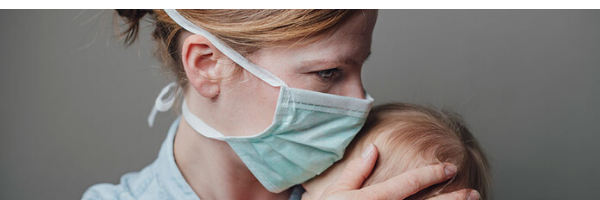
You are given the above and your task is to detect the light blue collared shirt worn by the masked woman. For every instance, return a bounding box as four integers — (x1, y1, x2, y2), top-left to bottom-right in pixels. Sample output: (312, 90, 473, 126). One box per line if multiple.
(82, 118, 304, 200)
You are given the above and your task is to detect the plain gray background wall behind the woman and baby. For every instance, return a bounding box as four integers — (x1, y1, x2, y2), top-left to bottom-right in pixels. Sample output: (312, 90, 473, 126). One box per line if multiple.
(0, 10, 600, 199)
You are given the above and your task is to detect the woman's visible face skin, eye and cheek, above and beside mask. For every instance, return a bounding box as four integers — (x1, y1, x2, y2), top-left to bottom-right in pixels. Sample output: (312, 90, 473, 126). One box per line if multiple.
(213, 10, 377, 135)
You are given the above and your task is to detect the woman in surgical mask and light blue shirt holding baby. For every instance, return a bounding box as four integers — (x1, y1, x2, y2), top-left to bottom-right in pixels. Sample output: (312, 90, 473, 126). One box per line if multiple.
(83, 10, 478, 199)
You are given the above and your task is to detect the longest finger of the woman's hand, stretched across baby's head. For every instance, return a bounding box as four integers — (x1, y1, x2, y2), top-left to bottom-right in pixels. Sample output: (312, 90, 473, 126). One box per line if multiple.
(359, 163, 456, 199)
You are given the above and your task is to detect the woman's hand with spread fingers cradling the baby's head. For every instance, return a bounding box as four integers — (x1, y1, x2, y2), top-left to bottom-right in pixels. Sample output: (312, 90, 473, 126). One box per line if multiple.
(319, 144, 480, 200)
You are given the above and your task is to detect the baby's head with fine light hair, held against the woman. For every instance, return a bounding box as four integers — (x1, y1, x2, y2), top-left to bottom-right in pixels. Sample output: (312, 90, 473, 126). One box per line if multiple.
(302, 103, 490, 199)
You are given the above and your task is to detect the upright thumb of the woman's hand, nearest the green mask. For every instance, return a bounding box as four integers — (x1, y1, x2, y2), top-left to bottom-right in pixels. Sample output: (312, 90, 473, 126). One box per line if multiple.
(326, 144, 378, 194)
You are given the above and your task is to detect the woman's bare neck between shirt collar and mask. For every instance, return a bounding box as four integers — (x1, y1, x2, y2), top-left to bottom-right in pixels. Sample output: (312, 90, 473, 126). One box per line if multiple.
(173, 119, 291, 200)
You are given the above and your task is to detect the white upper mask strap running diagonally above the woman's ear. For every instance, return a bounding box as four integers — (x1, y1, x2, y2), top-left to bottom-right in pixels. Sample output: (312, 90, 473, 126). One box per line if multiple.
(165, 9, 287, 87)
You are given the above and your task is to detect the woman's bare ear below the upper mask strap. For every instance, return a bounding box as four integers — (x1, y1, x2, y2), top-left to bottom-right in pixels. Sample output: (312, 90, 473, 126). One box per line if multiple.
(181, 35, 224, 99)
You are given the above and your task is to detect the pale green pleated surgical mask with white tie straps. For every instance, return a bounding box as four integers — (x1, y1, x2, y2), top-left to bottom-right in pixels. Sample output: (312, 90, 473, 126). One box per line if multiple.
(148, 10, 373, 193)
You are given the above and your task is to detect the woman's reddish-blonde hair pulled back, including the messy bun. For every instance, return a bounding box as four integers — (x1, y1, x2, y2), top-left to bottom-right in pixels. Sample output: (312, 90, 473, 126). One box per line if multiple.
(117, 9, 357, 87)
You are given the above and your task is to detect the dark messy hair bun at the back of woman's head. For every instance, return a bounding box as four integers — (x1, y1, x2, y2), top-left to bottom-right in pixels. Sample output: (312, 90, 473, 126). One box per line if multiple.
(117, 9, 154, 46)
